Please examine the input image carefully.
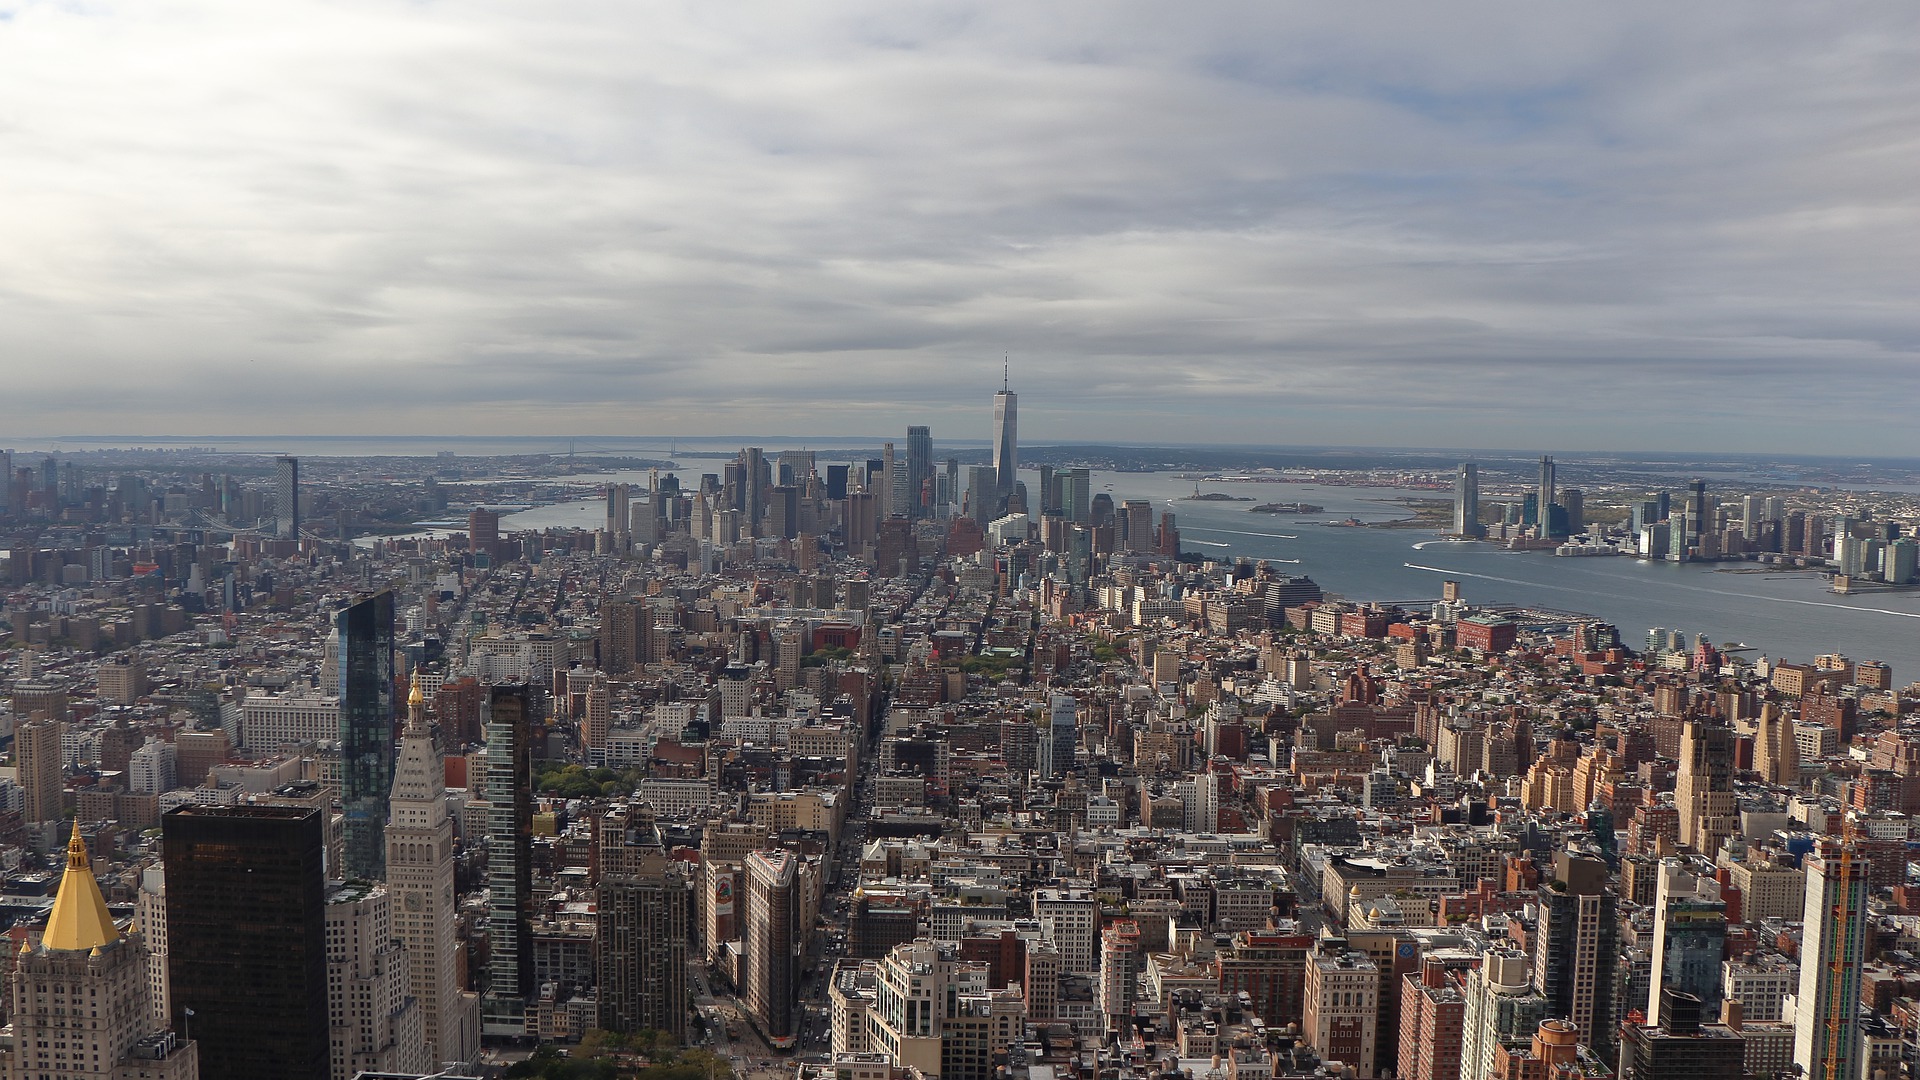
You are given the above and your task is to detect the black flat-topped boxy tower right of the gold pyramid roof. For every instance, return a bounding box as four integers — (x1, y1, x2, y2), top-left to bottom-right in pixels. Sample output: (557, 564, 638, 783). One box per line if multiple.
(161, 805, 330, 1080)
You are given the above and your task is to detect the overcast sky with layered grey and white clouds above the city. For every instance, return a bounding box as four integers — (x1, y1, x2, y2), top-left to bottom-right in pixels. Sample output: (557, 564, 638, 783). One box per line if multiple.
(0, 0, 1920, 454)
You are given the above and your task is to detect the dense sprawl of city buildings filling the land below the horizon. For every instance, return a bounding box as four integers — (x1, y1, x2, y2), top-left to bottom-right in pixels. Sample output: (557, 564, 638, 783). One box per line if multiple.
(0, 403, 1920, 1080)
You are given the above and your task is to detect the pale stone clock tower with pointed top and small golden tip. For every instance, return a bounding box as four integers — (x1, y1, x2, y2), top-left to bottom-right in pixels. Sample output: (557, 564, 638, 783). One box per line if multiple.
(386, 676, 480, 1067)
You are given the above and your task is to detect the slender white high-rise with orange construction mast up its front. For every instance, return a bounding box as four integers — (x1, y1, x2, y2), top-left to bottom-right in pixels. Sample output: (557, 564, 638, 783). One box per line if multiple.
(1793, 838, 1870, 1080)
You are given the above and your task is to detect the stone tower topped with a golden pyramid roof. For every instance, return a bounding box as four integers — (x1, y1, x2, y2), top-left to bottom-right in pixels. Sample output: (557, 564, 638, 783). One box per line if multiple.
(8, 822, 200, 1080)
